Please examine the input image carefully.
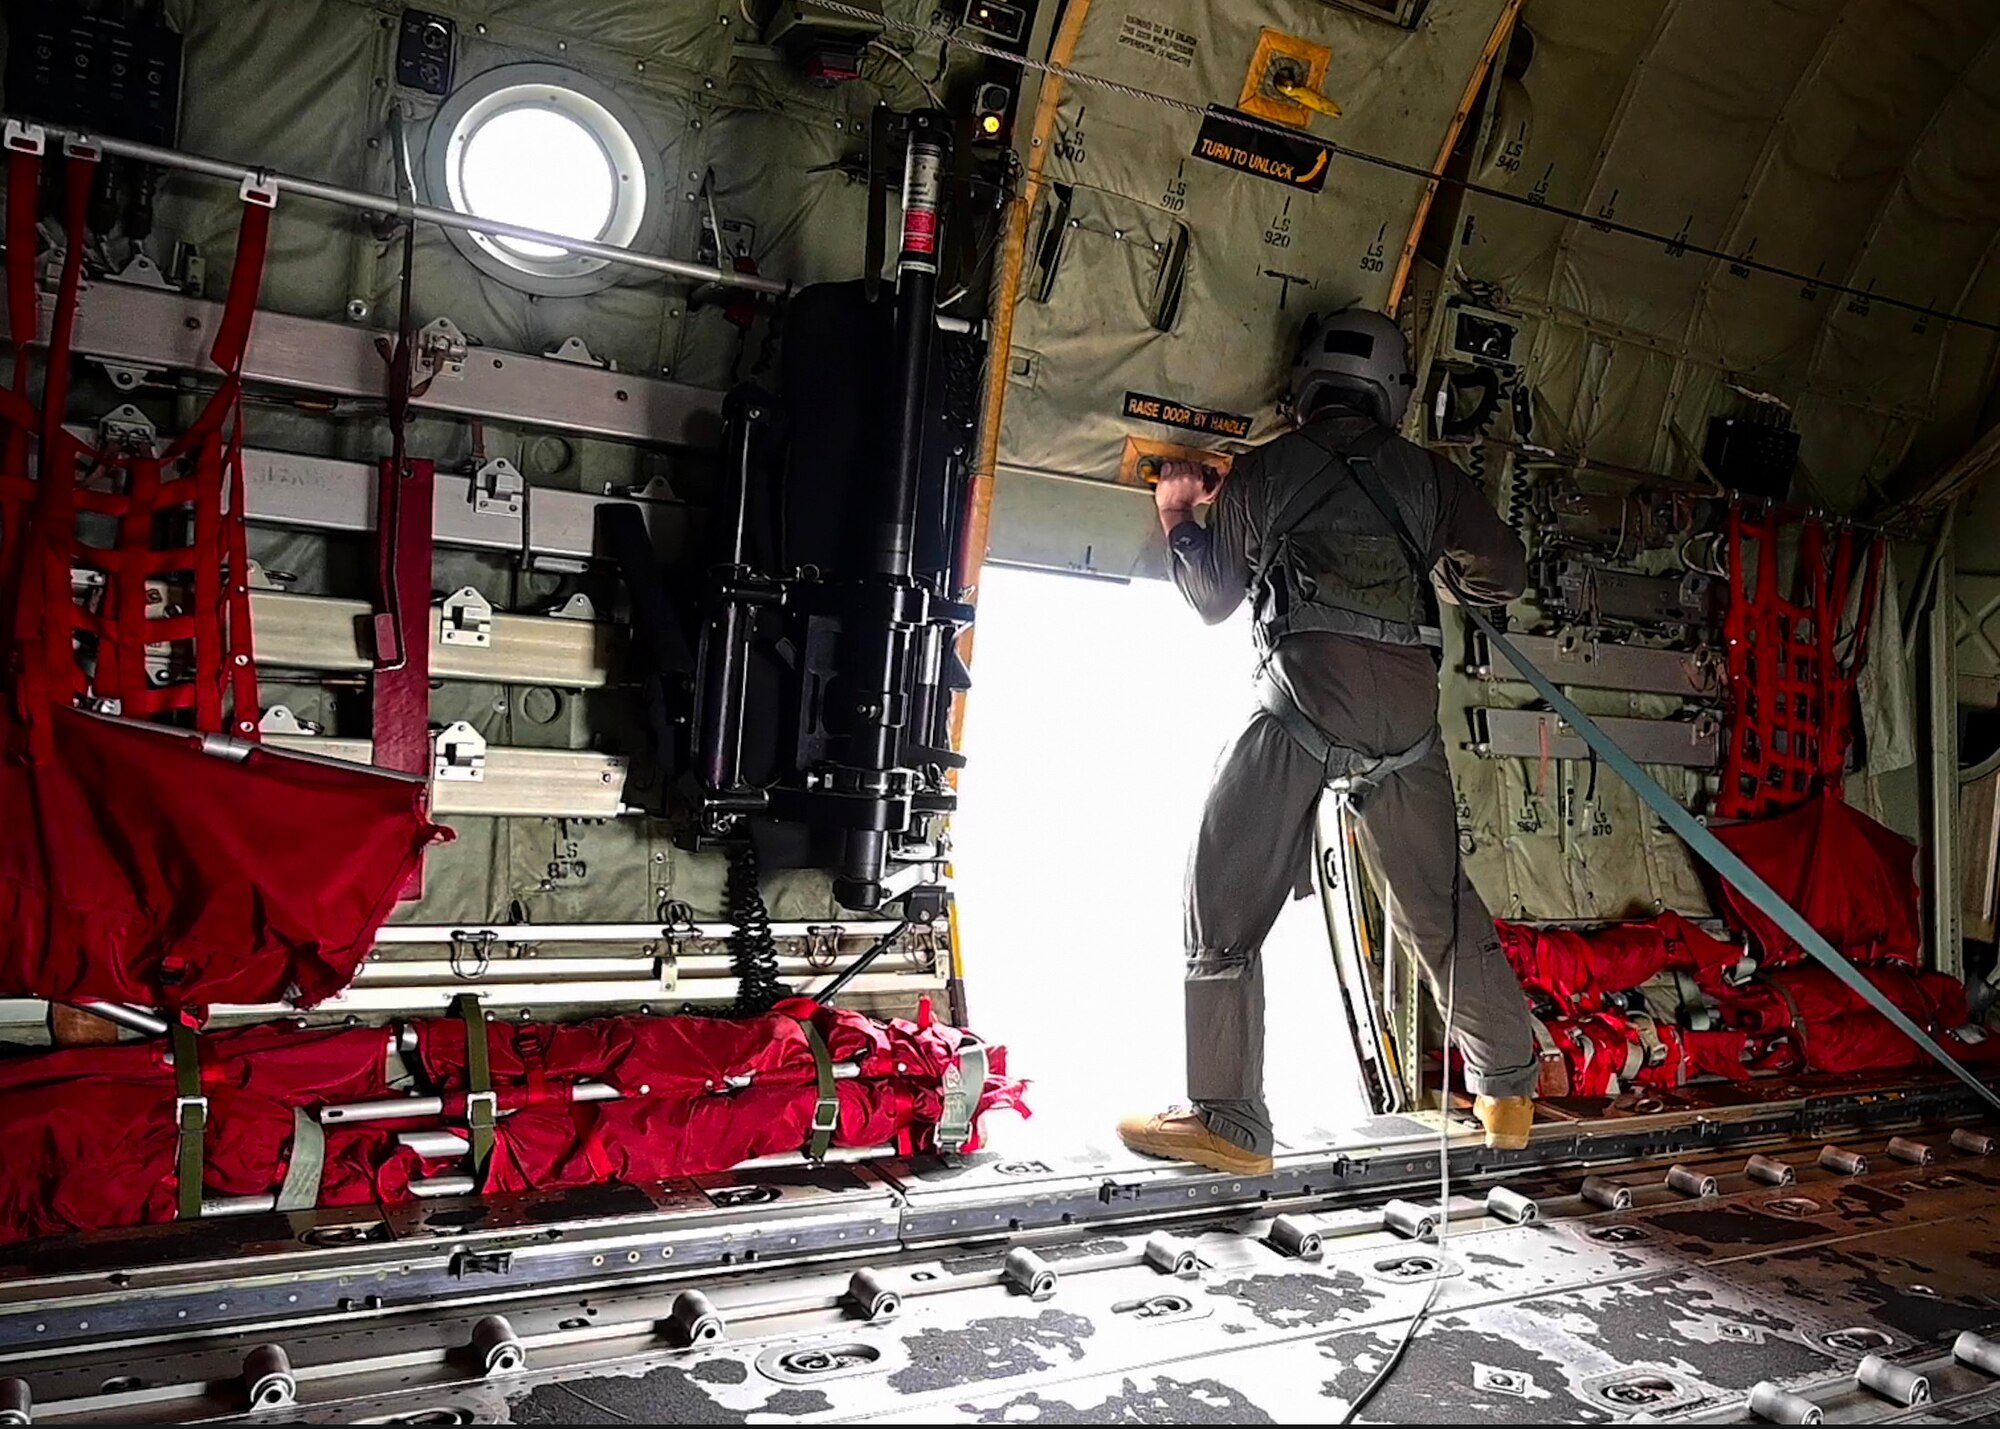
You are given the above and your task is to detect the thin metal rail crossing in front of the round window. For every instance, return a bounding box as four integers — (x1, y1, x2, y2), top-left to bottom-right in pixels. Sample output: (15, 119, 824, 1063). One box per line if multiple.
(0, 114, 974, 332)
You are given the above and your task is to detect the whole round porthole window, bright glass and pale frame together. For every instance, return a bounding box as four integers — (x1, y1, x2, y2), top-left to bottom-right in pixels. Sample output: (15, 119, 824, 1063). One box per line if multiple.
(424, 64, 660, 296)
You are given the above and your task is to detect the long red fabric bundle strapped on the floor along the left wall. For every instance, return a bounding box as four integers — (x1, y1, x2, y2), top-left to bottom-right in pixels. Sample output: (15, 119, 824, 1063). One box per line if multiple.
(0, 1003, 1026, 1241)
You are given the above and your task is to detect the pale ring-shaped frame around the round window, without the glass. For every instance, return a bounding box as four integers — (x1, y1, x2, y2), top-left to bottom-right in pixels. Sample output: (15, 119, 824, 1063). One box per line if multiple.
(424, 64, 666, 298)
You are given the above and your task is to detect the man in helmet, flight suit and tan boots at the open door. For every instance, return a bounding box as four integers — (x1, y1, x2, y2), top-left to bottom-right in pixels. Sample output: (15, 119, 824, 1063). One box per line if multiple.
(1118, 308, 1536, 1175)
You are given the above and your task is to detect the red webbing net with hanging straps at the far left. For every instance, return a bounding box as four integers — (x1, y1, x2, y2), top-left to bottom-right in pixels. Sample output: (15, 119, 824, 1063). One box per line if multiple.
(0, 152, 270, 755)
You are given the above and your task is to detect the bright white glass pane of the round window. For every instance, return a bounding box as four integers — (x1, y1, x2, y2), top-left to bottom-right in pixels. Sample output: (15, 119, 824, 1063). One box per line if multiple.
(460, 104, 618, 258)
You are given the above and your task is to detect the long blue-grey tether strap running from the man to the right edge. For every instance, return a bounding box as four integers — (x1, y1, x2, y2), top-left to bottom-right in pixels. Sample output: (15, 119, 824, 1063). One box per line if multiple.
(1348, 444, 2000, 1111)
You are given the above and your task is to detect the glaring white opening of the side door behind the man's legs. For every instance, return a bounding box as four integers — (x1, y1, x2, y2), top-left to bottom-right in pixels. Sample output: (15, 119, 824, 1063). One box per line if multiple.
(952, 566, 1366, 1147)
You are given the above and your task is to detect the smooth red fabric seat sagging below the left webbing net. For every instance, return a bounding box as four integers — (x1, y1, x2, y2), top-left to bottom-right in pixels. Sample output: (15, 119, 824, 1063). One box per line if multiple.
(0, 700, 446, 1009)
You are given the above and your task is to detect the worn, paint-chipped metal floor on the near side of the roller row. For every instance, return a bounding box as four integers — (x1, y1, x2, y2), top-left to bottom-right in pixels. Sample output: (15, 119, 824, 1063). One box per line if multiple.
(27, 1141, 2000, 1423)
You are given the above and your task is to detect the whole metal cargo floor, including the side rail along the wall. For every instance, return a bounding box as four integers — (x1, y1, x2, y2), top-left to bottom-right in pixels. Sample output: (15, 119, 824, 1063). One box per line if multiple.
(11, 1099, 2000, 1423)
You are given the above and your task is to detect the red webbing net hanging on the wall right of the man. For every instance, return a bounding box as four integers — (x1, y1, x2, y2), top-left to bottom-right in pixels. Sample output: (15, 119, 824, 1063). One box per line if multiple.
(1716, 506, 1882, 819)
